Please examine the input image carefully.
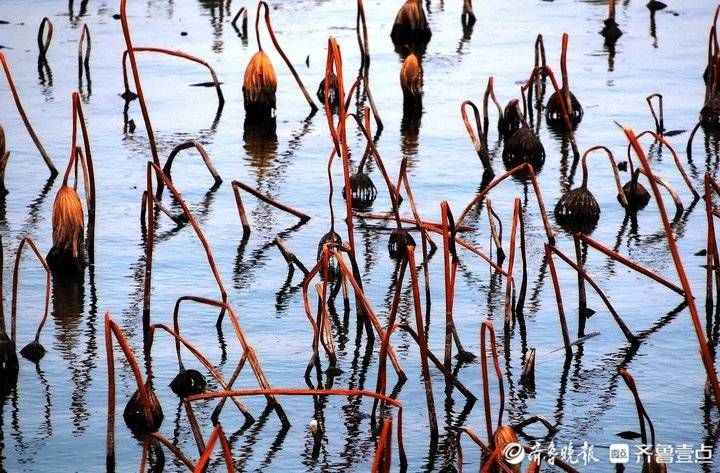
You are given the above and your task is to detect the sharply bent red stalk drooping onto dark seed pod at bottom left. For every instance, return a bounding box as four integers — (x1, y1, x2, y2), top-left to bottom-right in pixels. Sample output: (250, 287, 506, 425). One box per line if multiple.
(105, 312, 156, 469)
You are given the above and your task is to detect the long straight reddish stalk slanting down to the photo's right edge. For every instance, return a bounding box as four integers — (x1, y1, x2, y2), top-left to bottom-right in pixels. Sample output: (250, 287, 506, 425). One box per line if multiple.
(624, 128, 720, 409)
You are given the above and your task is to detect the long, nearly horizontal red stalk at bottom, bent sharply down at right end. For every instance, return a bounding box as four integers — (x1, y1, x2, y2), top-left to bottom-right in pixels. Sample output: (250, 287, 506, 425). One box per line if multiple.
(187, 388, 407, 468)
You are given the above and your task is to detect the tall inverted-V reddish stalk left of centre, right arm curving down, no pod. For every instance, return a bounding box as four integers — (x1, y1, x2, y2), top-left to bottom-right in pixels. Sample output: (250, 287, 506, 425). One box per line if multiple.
(143, 162, 227, 336)
